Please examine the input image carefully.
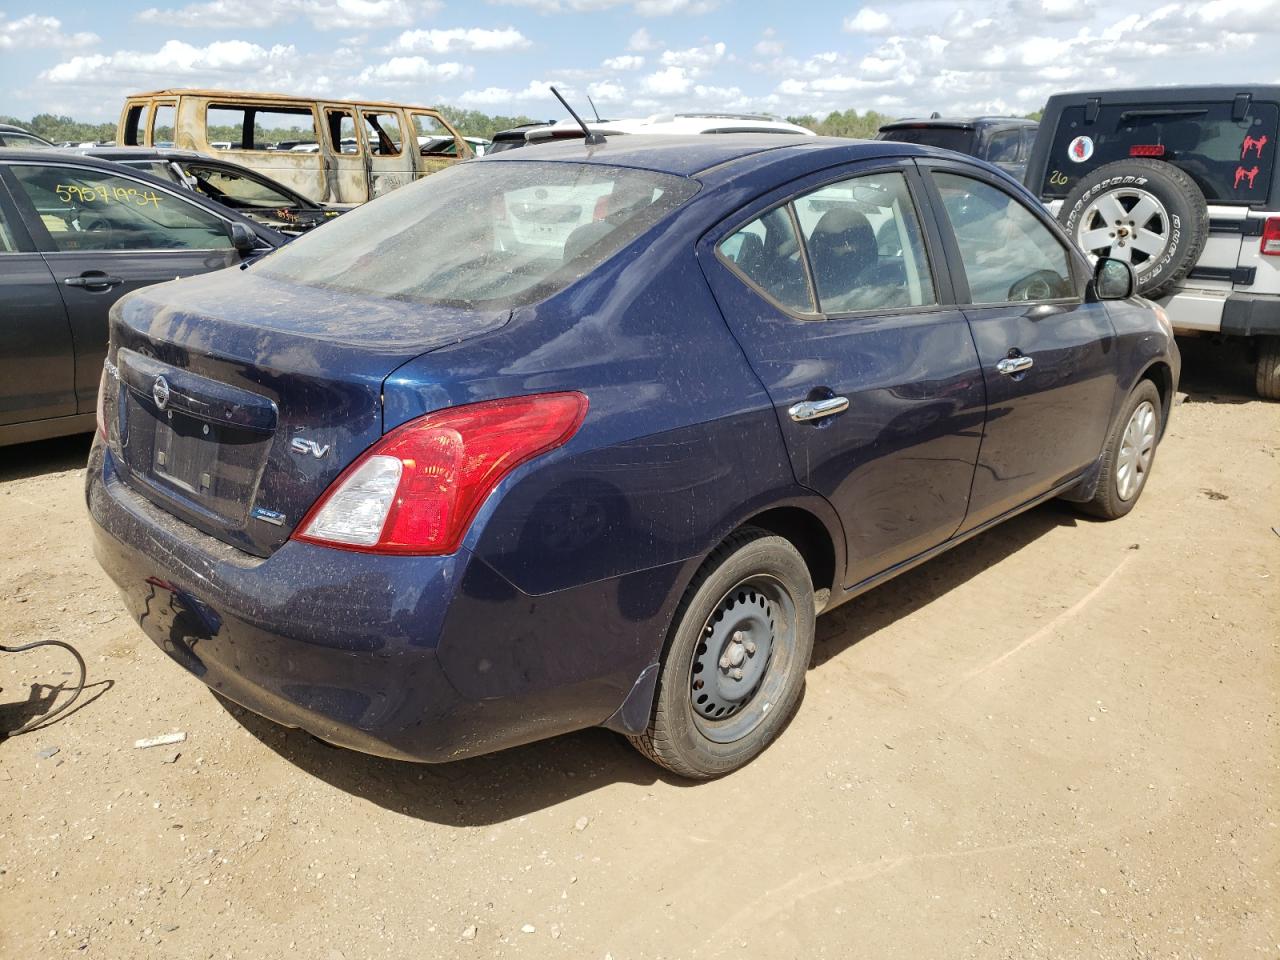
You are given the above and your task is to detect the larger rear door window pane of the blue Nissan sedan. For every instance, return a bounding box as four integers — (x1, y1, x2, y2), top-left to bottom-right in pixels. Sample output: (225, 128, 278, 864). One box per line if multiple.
(795, 173, 937, 314)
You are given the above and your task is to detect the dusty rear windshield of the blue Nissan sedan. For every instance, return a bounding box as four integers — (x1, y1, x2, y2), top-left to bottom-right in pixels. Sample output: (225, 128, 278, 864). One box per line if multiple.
(253, 161, 698, 308)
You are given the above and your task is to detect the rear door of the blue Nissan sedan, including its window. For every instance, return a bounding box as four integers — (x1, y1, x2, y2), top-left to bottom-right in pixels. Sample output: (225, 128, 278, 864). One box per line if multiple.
(699, 160, 984, 586)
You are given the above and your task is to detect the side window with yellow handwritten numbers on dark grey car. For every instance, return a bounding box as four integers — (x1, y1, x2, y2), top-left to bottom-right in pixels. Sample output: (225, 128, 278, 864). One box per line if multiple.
(9, 164, 232, 251)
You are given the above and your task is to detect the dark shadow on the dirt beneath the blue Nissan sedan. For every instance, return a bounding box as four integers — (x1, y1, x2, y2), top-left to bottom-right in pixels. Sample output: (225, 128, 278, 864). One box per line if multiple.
(222, 503, 1076, 827)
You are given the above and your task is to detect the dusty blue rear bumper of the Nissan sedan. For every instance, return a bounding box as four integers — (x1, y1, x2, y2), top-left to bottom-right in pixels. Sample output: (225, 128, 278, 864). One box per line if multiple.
(87, 439, 669, 762)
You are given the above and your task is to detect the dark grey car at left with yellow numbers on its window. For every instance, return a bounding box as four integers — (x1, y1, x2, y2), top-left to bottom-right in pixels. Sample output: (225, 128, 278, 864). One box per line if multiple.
(0, 150, 288, 445)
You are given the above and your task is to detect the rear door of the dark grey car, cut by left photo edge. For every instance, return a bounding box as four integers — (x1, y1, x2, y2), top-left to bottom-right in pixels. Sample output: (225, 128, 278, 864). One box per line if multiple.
(0, 174, 76, 424)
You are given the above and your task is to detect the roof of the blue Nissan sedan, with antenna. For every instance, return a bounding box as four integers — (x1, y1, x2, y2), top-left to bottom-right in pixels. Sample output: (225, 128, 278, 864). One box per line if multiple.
(481, 133, 955, 178)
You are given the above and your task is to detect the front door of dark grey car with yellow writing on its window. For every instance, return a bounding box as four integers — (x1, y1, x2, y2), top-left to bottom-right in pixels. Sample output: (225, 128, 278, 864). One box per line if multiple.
(6, 161, 239, 413)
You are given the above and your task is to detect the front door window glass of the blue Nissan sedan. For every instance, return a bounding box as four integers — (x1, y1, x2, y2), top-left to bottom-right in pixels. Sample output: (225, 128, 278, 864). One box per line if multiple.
(933, 173, 1076, 303)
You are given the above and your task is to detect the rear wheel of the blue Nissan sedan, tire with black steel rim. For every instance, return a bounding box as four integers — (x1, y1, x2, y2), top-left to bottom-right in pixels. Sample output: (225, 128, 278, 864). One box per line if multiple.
(628, 527, 815, 780)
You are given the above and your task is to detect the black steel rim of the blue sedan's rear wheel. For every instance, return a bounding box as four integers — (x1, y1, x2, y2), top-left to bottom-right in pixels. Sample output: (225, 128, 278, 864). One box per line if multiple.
(689, 575, 796, 744)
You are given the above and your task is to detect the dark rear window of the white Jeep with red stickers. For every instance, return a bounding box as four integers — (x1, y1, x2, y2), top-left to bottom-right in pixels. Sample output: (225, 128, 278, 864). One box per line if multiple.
(1041, 101, 1280, 204)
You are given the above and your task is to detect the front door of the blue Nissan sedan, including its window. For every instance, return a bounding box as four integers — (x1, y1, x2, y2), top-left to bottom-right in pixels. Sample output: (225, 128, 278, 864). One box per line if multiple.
(920, 160, 1117, 530)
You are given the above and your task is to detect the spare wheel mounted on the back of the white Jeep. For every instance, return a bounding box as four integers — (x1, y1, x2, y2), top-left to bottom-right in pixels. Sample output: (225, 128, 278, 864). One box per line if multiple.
(1057, 160, 1208, 298)
